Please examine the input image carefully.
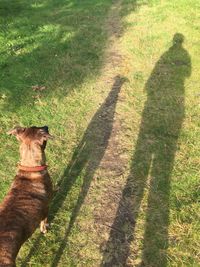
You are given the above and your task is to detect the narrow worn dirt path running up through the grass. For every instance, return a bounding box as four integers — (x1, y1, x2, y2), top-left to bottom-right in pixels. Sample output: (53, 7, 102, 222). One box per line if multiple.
(73, 1, 133, 266)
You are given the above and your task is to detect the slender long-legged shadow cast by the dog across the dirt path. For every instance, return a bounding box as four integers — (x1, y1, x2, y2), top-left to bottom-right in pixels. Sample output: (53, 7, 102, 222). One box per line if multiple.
(18, 76, 125, 267)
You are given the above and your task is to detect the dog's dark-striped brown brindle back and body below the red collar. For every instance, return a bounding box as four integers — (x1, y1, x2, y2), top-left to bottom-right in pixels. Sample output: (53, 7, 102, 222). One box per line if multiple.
(0, 172, 52, 266)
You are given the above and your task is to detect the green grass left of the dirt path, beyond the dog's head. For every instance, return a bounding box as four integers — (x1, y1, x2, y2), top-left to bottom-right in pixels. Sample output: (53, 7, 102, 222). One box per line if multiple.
(0, 1, 114, 191)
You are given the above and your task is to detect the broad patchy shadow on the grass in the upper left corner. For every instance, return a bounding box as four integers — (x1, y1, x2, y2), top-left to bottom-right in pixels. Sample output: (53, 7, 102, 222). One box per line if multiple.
(0, 0, 117, 111)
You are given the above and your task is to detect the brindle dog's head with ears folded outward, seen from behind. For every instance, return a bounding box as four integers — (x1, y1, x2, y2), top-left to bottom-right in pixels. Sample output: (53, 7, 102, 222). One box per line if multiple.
(8, 126, 53, 150)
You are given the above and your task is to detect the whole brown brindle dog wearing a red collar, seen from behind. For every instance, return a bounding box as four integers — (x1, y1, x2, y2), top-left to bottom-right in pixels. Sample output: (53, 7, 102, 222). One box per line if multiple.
(0, 126, 52, 267)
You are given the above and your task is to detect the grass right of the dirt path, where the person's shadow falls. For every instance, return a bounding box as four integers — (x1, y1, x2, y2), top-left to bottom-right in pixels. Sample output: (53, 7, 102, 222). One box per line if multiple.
(108, 0, 200, 266)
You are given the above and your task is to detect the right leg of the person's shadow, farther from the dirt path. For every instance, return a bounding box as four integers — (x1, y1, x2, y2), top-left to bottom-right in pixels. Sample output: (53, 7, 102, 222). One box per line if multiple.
(141, 138, 177, 267)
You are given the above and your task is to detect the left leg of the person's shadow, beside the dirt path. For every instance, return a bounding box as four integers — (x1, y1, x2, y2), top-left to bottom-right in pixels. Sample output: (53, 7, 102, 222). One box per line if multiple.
(101, 131, 153, 267)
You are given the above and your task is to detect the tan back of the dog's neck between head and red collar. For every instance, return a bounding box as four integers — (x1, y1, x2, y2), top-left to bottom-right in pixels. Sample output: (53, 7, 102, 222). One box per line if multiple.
(20, 143, 46, 167)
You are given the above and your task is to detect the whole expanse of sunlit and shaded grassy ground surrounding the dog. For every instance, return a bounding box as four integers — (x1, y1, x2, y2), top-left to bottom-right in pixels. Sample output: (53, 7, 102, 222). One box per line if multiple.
(0, 0, 200, 267)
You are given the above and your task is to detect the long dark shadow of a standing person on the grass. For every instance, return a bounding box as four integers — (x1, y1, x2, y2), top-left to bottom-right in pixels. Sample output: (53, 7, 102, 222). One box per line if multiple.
(101, 33, 191, 267)
